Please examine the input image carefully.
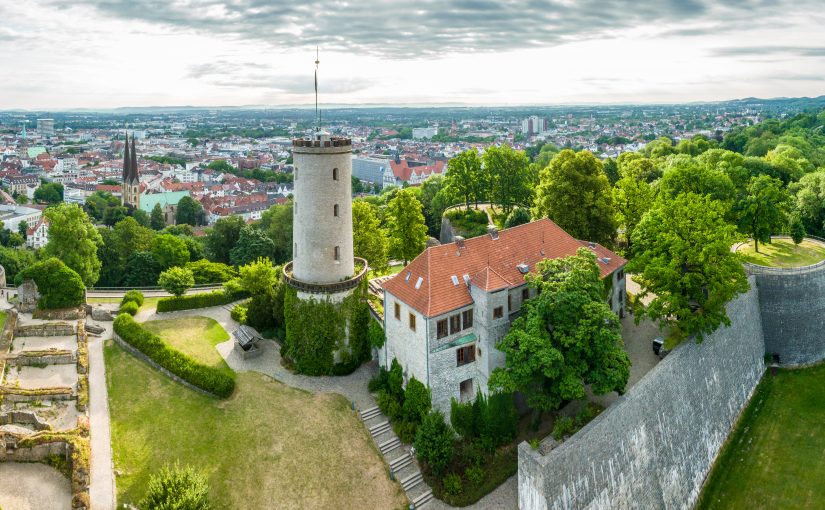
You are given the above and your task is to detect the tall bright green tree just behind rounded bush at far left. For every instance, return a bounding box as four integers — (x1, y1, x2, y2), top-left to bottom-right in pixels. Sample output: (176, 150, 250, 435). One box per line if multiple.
(43, 204, 103, 286)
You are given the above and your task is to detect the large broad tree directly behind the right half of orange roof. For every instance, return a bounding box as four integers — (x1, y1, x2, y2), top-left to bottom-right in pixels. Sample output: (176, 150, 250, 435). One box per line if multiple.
(533, 149, 616, 245)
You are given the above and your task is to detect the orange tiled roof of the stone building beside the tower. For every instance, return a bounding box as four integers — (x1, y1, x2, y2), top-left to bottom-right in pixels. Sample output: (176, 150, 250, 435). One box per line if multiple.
(382, 219, 627, 317)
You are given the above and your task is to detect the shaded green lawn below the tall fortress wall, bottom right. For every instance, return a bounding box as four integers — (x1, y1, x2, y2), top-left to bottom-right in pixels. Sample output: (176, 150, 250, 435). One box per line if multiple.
(697, 364, 825, 509)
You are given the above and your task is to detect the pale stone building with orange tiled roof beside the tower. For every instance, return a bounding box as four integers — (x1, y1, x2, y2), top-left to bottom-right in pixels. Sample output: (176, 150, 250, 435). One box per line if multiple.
(379, 219, 627, 415)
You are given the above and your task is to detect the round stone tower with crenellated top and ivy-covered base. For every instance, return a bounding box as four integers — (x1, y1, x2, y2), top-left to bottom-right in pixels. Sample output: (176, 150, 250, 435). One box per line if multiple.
(283, 133, 370, 375)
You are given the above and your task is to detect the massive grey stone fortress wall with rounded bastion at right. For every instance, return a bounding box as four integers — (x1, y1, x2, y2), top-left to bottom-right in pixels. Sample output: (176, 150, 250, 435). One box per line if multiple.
(518, 263, 825, 510)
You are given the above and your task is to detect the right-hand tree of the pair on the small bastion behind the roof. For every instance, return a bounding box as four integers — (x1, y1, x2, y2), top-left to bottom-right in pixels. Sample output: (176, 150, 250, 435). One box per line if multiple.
(480, 145, 535, 214)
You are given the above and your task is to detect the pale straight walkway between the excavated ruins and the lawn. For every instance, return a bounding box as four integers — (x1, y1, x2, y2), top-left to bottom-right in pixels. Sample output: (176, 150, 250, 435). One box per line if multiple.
(88, 320, 116, 510)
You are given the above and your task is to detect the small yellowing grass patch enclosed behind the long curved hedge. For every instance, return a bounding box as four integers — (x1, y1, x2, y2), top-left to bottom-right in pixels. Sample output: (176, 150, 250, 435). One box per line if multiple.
(141, 316, 232, 373)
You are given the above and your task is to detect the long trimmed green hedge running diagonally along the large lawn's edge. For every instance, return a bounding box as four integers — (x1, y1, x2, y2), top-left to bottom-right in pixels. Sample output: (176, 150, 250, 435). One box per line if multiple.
(114, 314, 235, 398)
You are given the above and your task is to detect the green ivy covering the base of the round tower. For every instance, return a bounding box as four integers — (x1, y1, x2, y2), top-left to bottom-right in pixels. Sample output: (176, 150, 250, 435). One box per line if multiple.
(284, 281, 370, 375)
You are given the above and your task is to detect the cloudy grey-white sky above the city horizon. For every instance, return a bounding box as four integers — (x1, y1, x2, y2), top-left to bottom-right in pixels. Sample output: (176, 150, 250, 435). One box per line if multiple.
(0, 0, 825, 109)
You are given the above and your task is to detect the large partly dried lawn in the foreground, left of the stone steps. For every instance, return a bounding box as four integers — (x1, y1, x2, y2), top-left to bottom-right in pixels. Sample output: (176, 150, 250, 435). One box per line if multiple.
(104, 341, 406, 509)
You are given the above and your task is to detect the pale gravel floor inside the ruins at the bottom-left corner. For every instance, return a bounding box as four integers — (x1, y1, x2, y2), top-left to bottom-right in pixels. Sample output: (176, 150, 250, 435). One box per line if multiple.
(0, 462, 72, 510)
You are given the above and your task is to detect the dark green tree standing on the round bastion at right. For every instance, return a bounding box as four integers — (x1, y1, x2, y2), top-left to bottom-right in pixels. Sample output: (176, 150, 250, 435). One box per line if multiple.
(737, 175, 790, 253)
